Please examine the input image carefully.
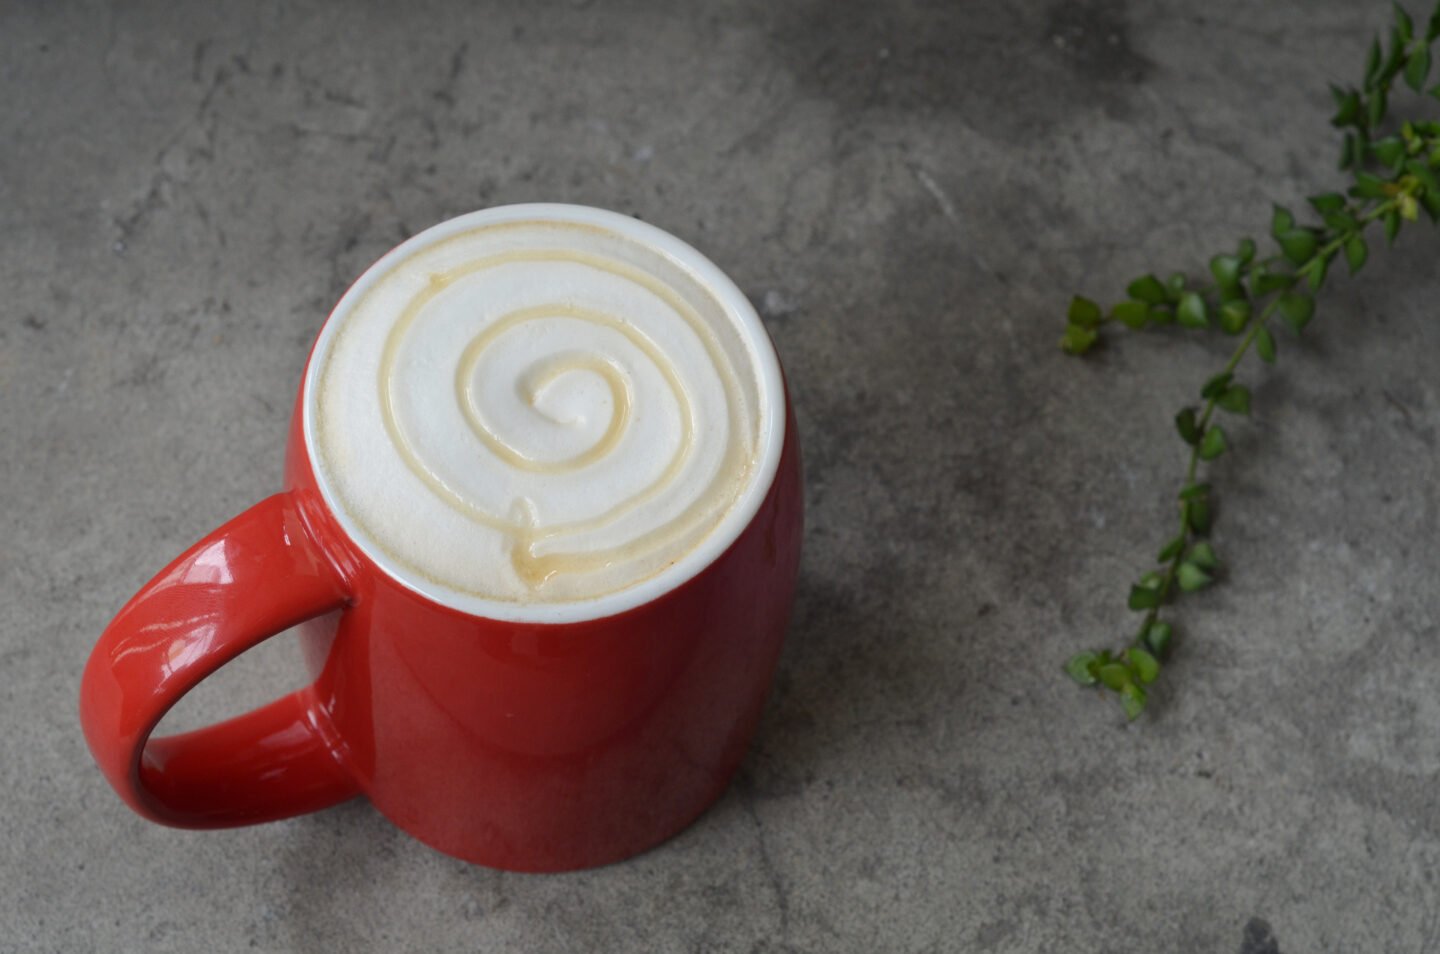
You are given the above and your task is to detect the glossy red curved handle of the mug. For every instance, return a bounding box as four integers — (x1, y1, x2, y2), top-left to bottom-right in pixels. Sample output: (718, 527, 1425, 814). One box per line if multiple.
(81, 491, 359, 829)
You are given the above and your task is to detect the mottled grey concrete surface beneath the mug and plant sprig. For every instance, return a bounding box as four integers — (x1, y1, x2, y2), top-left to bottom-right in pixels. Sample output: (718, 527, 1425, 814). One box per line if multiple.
(0, 0, 1440, 954)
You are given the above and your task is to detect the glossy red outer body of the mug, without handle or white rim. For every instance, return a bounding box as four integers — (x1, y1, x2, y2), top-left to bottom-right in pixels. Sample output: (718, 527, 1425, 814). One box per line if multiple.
(287, 391, 802, 870)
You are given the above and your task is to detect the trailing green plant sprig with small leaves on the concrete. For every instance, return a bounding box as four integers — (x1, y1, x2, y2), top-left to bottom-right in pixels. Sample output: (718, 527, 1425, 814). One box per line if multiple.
(1060, 3, 1440, 719)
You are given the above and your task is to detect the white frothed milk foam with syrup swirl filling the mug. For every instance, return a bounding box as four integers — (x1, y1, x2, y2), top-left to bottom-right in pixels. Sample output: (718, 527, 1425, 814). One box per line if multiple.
(305, 206, 783, 605)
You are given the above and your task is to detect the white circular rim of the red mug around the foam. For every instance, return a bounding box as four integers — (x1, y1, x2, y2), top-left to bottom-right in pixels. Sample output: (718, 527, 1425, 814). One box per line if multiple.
(301, 202, 789, 624)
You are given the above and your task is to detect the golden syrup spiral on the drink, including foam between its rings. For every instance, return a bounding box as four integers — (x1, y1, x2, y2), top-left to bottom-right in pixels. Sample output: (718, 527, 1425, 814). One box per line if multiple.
(360, 249, 756, 598)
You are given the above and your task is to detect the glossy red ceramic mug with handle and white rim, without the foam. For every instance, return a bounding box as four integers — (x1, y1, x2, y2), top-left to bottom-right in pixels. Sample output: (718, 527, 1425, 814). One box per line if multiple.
(81, 205, 802, 872)
